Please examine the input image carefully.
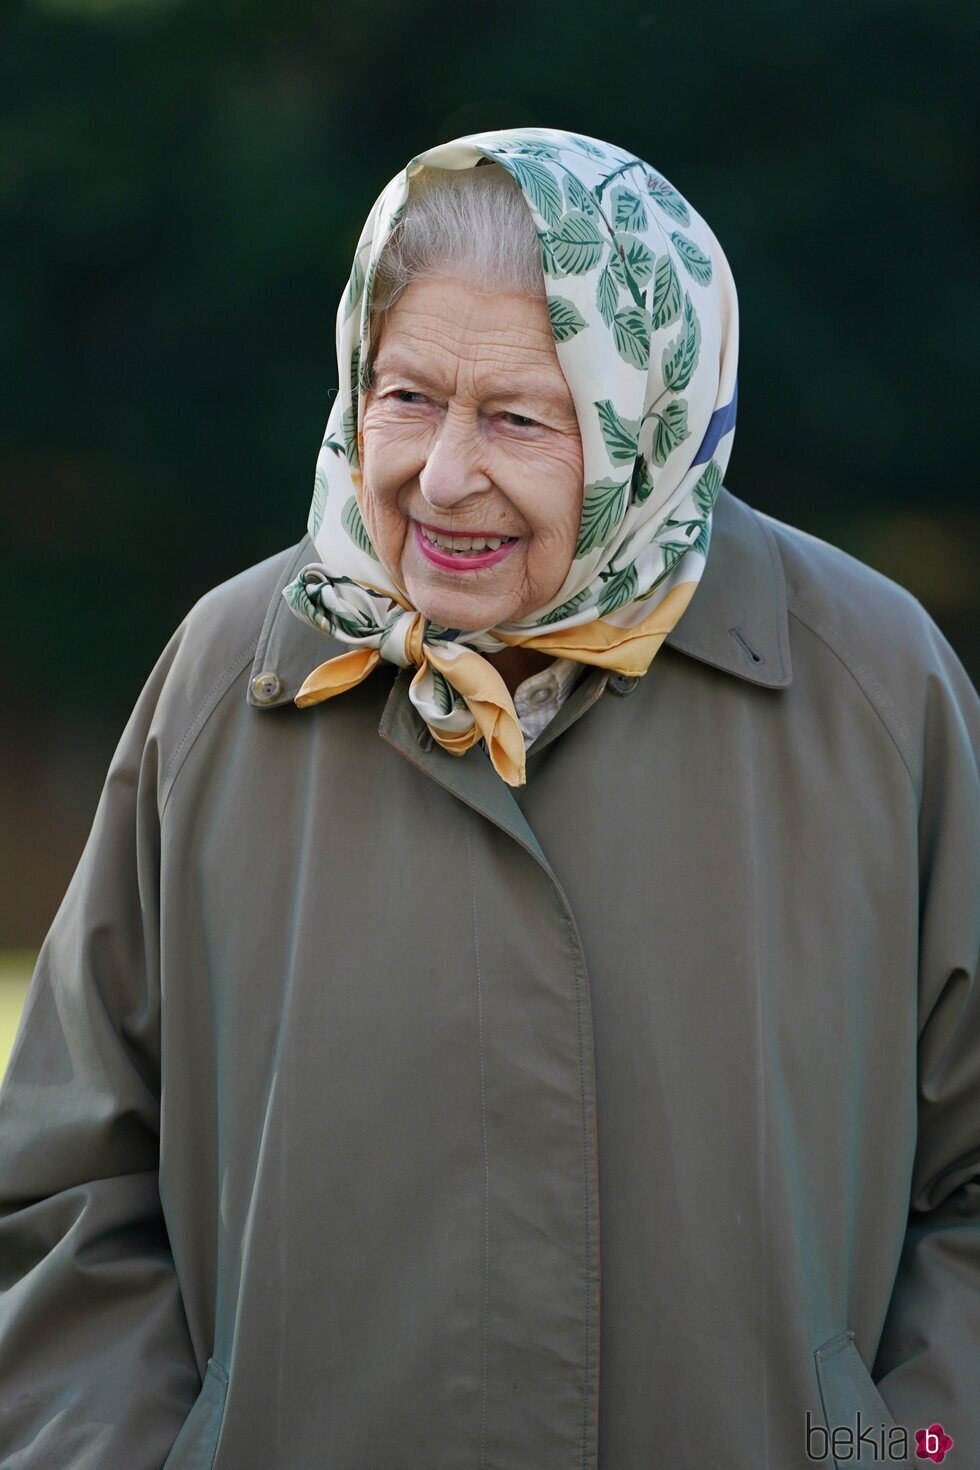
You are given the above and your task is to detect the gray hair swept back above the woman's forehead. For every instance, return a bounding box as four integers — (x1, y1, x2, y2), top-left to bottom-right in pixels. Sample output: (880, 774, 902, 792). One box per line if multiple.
(370, 163, 545, 329)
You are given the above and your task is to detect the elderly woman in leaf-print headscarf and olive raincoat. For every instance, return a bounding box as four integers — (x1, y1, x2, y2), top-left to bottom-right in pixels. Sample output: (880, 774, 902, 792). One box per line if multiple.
(0, 129, 980, 1470)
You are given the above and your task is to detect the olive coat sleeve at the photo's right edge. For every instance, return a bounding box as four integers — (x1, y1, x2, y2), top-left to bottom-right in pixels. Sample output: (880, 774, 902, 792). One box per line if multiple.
(874, 623, 980, 1446)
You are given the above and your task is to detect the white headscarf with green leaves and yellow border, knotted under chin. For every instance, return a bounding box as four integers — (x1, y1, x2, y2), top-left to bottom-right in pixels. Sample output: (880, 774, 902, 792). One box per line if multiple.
(282, 128, 738, 786)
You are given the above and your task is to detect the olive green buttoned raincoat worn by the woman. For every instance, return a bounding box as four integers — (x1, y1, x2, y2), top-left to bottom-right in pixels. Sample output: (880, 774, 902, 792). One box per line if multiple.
(0, 492, 980, 1470)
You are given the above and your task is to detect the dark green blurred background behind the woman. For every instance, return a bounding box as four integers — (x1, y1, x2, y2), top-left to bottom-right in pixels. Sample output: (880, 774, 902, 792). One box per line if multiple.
(0, 0, 980, 948)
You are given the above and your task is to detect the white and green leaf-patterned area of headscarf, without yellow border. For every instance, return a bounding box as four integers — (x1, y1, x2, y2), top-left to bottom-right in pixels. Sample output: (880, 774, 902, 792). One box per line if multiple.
(290, 128, 738, 729)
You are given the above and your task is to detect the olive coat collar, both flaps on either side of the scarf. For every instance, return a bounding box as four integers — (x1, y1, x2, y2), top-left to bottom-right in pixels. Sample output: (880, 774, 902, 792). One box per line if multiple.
(247, 490, 792, 713)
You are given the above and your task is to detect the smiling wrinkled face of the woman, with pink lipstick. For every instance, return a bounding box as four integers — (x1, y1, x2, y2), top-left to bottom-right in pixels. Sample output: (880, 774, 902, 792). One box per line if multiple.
(361, 276, 583, 631)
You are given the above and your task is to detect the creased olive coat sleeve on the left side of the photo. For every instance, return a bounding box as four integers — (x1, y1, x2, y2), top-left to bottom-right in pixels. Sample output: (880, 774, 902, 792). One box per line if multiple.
(0, 625, 201, 1470)
